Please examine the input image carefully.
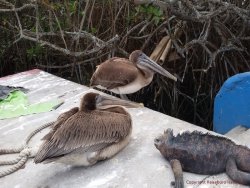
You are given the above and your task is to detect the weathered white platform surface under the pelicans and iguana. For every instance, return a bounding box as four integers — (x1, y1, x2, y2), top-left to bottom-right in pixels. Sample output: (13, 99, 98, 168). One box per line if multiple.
(0, 69, 250, 188)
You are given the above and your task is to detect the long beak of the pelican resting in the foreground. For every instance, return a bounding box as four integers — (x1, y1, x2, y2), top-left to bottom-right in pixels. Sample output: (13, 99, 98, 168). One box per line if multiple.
(96, 95, 144, 109)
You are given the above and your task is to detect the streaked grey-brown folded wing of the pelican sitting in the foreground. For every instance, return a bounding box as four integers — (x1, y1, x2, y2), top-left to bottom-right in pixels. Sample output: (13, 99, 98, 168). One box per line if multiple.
(34, 110, 132, 163)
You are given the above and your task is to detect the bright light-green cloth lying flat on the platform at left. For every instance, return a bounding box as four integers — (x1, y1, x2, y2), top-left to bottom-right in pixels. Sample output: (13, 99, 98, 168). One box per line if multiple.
(0, 90, 62, 119)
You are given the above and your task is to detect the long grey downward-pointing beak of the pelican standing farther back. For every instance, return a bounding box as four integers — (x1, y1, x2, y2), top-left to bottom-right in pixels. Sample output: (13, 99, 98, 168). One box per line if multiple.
(138, 54, 177, 81)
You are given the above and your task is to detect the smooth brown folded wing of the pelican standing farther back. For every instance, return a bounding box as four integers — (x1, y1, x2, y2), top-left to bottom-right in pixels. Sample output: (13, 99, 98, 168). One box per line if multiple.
(90, 57, 139, 89)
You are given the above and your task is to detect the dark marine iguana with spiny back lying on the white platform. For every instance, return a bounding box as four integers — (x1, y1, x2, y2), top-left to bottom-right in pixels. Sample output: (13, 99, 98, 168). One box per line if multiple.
(154, 129, 250, 188)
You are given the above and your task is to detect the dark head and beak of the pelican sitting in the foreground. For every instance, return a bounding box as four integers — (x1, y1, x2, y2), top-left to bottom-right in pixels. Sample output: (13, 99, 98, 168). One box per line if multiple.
(80, 92, 143, 111)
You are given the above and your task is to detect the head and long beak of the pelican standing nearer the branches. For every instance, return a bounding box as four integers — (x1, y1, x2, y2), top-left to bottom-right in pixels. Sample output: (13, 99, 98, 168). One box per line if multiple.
(129, 50, 177, 81)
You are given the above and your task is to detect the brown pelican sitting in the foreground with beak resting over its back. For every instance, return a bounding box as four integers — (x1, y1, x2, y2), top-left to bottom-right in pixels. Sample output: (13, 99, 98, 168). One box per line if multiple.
(34, 92, 141, 166)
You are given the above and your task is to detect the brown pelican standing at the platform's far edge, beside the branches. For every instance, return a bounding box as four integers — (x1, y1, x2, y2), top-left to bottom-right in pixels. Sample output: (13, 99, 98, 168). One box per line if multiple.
(90, 50, 177, 94)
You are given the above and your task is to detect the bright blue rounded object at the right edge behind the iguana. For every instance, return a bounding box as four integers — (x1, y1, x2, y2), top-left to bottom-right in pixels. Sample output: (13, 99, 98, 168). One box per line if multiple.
(213, 72, 250, 134)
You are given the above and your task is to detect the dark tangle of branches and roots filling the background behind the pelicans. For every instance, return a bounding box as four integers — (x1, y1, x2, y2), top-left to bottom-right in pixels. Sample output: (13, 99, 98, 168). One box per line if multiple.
(0, 0, 250, 129)
